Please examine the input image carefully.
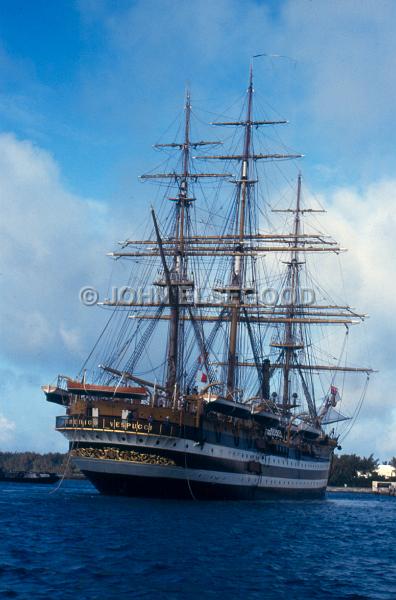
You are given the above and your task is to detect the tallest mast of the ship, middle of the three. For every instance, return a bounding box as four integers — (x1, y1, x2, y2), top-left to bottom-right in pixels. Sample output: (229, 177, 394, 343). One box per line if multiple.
(227, 64, 253, 397)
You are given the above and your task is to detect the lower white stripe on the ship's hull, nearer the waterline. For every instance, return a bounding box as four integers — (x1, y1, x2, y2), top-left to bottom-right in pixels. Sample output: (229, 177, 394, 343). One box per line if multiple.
(73, 457, 327, 491)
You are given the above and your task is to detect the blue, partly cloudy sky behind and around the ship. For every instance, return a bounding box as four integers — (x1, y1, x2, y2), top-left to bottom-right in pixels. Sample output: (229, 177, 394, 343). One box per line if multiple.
(0, 0, 396, 460)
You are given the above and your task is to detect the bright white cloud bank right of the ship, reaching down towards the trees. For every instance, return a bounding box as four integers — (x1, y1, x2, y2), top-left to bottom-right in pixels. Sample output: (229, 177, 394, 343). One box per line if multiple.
(308, 179, 396, 460)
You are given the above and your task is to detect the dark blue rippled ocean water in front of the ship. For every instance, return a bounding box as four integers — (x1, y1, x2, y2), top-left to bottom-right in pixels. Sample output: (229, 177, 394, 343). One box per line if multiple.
(0, 481, 396, 600)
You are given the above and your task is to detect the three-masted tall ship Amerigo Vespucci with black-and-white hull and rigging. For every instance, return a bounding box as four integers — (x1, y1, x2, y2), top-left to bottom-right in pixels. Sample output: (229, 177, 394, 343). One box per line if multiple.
(43, 68, 371, 500)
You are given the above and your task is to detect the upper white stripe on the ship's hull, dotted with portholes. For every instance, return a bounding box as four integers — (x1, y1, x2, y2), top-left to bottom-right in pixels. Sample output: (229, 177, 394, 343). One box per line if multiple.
(62, 430, 330, 471)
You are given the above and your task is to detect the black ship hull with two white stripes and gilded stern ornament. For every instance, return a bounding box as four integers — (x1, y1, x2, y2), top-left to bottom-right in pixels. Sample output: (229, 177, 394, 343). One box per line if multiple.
(63, 429, 331, 500)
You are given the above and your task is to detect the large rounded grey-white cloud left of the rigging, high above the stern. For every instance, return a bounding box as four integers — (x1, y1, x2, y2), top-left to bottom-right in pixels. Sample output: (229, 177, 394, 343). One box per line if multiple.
(0, 135, 124, 368)
